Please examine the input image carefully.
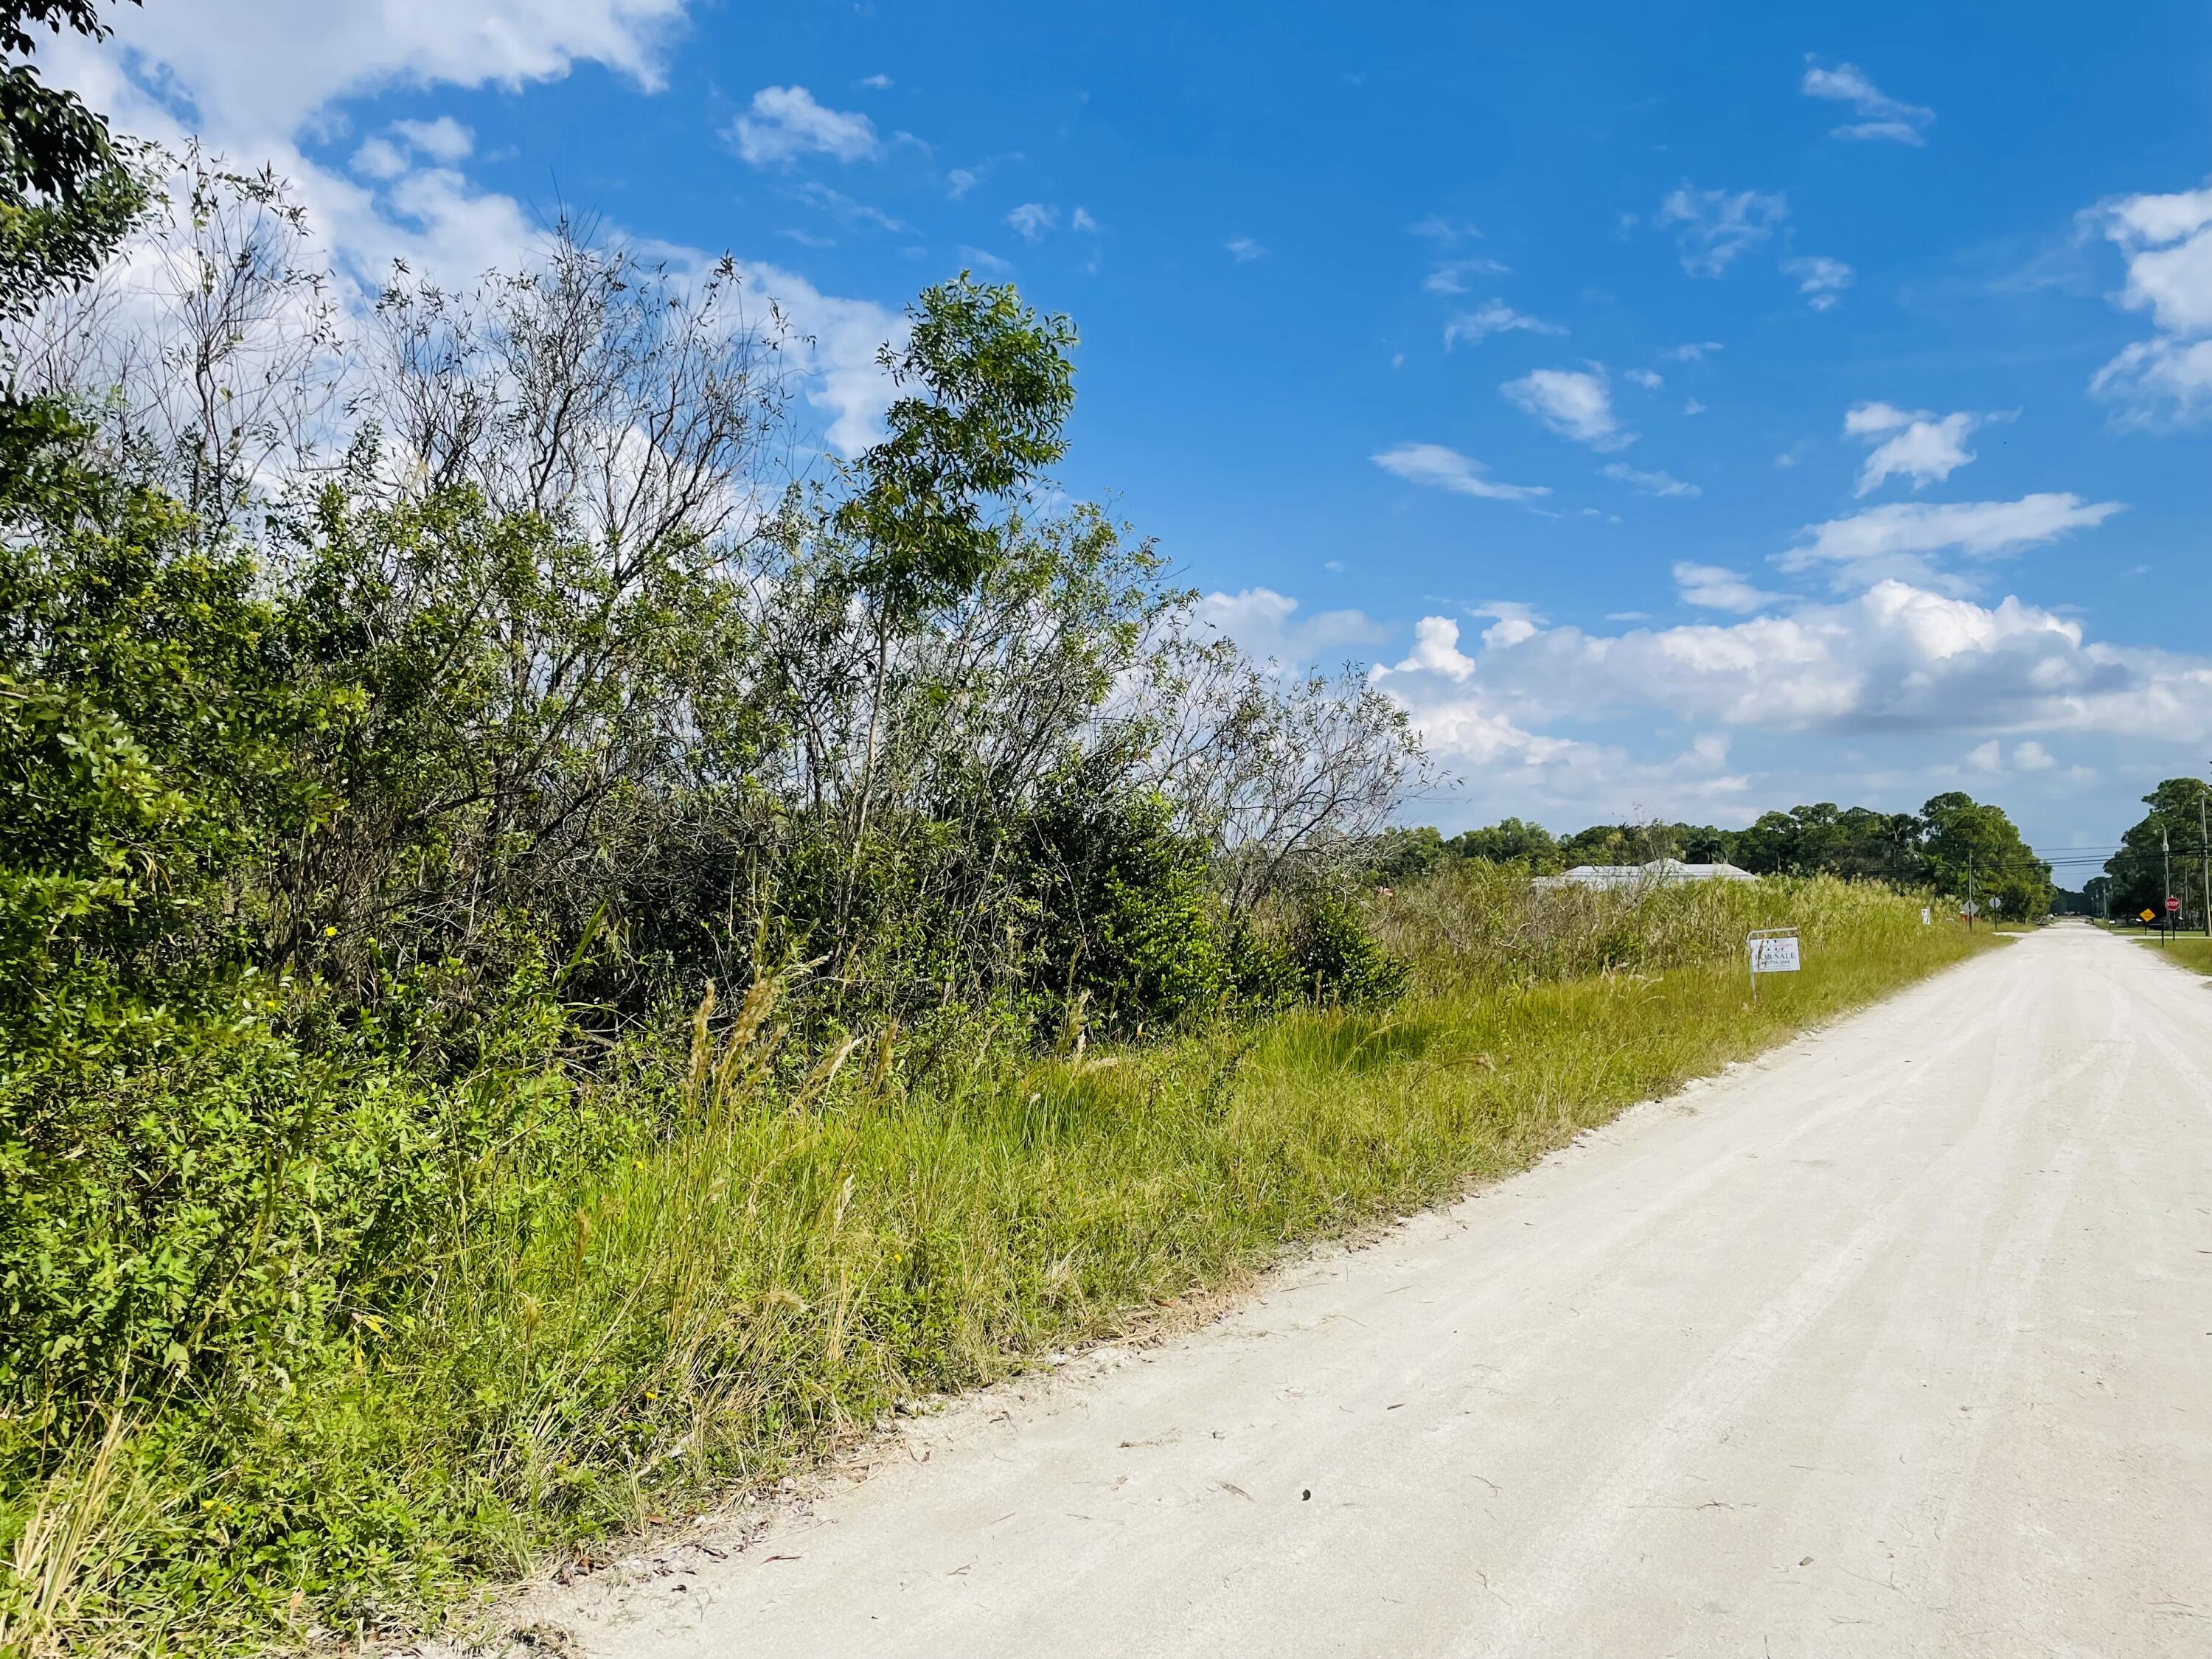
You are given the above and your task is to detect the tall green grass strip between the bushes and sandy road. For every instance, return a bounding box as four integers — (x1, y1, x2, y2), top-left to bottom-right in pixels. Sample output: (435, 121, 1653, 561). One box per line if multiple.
(0, 883, 1995, 1652)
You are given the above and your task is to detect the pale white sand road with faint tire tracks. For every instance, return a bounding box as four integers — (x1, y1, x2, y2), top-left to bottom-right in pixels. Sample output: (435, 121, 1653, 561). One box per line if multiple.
(489, 925, 2212, 1659)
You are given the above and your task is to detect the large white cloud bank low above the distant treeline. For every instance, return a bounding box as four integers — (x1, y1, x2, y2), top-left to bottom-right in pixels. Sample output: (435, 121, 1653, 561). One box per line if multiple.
(1374, 584, 2212, 827)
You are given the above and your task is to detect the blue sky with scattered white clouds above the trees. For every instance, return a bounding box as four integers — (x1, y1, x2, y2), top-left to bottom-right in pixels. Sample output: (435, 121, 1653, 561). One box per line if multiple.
(73, 0, 2212, 847)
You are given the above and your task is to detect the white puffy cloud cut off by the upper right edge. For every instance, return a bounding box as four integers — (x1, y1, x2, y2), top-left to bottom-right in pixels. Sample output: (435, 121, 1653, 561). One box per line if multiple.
(2084, 184, 2212, 427)
